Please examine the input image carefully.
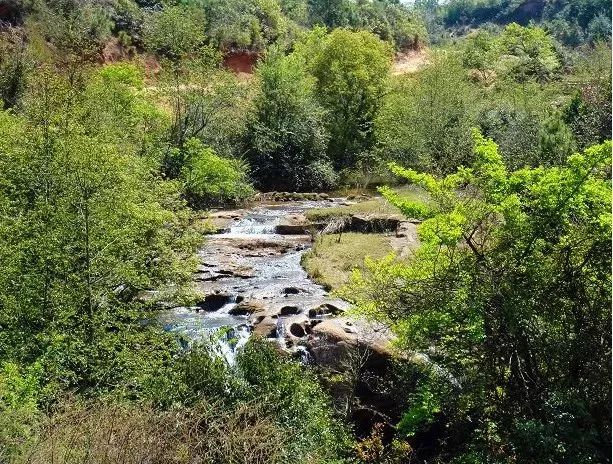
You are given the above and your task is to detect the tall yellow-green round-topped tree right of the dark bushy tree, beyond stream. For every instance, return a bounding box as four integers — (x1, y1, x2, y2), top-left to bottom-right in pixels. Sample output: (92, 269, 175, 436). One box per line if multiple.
(302, 29, 392, 168)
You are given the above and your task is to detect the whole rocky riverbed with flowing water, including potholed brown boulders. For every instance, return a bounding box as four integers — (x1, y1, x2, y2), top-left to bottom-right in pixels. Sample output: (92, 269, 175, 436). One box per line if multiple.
(160, 199, 389, 366)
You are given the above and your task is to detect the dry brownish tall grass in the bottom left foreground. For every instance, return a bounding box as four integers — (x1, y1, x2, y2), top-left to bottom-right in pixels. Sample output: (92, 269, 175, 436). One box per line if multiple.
(8, 401, 288, 464)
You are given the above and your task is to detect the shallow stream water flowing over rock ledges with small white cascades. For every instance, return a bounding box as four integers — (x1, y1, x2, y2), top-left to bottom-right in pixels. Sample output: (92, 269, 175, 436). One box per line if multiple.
(160, 200, 347, 363)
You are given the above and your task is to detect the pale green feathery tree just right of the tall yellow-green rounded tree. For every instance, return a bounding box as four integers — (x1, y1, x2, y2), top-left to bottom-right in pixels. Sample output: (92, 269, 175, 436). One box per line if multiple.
(375, 55, 474, 173)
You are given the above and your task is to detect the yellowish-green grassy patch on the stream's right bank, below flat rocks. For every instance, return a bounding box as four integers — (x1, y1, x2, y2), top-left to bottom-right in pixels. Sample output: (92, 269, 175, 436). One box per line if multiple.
(302, 232, 393, 290)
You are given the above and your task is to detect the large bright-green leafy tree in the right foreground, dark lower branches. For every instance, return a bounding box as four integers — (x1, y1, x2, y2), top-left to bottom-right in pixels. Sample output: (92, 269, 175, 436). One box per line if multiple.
(346, 134, 611, 462)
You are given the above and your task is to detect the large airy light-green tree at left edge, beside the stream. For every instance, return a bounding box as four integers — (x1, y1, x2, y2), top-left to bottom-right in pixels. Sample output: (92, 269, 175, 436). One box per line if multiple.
(0, 68, 197, 395)
